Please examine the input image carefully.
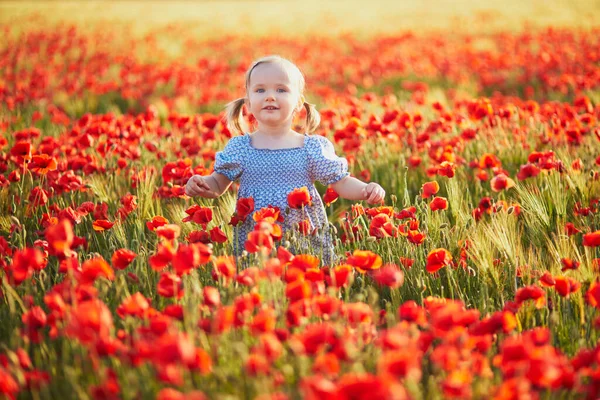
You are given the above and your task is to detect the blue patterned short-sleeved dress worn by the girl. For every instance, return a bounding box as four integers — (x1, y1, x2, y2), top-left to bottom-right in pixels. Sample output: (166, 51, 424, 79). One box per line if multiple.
(214, 134, 349, 265)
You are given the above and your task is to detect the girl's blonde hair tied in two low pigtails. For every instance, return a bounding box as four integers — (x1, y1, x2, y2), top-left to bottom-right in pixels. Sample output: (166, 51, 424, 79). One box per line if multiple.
(225, 55, 321, 134)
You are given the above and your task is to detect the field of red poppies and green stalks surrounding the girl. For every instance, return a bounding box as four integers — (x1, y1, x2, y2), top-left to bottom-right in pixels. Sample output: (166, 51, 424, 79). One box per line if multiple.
(0, 5, 600, 400)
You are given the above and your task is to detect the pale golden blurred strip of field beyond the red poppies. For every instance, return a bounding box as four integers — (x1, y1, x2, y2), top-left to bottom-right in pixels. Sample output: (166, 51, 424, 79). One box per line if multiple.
(0, 0, 600, 37)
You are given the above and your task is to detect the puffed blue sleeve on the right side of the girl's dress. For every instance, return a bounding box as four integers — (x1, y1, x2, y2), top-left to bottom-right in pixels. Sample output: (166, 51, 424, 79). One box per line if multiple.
(309, 135, 350, 185)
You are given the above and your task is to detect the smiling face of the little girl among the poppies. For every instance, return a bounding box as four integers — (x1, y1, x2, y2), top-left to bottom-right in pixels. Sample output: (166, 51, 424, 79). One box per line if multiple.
(247, 63, 302, 127)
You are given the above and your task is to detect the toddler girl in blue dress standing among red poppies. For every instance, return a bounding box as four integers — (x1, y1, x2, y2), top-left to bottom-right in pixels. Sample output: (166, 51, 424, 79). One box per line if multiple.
(185, 56, 385, 265)
